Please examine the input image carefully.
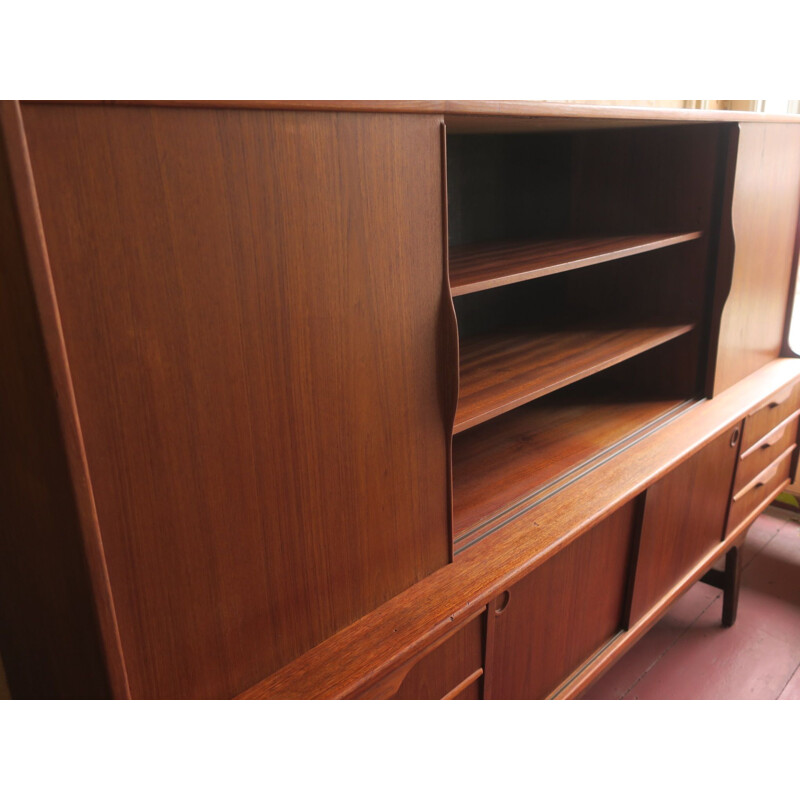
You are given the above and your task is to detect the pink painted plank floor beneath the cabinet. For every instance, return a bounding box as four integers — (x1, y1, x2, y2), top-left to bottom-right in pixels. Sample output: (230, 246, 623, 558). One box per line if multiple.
(584, 508, 800, 700)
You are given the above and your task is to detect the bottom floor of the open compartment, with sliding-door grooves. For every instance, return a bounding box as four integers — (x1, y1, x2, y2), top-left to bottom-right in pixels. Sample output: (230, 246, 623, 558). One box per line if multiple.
(453, 385, 695, 550)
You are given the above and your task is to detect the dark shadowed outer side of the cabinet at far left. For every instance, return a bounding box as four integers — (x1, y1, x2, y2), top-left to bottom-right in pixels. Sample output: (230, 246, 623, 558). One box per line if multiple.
(0, 114, 110, 699)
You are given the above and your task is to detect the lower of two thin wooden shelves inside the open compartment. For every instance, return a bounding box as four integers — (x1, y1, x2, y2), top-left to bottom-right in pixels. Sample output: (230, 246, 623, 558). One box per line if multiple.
(453, 325, 694, 433)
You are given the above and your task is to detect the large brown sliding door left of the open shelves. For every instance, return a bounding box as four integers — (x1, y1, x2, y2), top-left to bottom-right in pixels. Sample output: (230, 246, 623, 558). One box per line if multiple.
(24, 104, 449, 697)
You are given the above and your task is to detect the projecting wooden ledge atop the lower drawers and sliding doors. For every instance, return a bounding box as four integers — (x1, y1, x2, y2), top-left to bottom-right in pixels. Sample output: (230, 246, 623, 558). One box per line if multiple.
(241, 358, 800, 699)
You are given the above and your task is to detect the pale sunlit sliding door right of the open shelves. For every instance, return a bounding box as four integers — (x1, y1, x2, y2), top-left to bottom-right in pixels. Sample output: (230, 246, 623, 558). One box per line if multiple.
(714, 123, 800, 394)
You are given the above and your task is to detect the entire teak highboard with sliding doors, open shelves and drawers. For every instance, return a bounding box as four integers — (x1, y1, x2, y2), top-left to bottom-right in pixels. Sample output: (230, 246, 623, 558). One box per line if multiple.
(0, 101, 800, 699)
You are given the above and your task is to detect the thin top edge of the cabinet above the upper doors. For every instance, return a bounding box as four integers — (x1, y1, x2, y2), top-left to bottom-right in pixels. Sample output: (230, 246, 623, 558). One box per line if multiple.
(14, 100, 800, 126)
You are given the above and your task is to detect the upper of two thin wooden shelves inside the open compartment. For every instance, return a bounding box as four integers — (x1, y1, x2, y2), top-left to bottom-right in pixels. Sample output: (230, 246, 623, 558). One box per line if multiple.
(450, 231, 702, 296)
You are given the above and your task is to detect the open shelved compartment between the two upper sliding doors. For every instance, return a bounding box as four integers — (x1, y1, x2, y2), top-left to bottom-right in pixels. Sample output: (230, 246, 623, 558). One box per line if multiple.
(446, 125, 736, 555)
